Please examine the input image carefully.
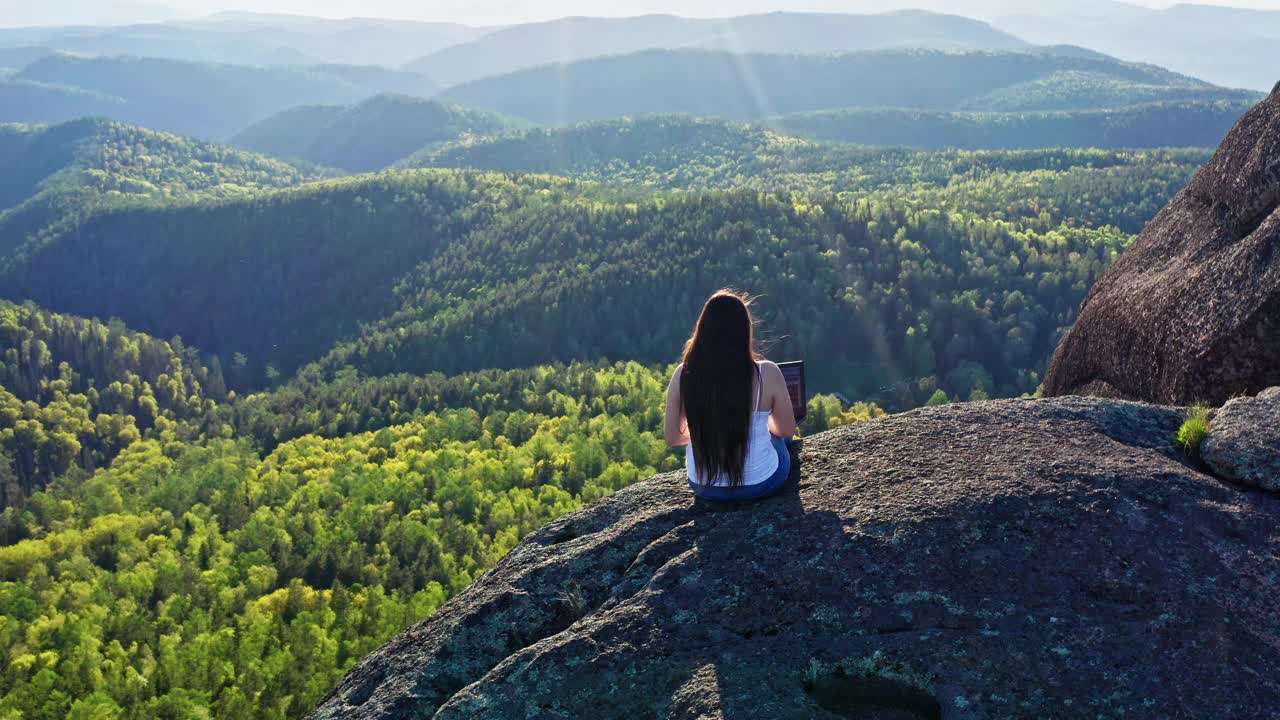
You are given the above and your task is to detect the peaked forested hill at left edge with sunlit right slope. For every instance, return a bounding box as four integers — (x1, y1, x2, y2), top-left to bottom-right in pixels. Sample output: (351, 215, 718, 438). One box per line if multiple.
(0, 119, 323, 264)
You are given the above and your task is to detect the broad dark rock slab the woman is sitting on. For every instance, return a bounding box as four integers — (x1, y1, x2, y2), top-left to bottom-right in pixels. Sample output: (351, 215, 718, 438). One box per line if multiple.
(312, 397, 1280, 720)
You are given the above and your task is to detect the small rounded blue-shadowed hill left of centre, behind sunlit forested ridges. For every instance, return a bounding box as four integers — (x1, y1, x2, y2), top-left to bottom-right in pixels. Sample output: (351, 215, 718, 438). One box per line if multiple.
(232, 95, 517, 173)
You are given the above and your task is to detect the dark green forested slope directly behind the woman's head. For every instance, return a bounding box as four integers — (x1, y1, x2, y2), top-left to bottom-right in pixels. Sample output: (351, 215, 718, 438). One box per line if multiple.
(314, 183, 1126, 397)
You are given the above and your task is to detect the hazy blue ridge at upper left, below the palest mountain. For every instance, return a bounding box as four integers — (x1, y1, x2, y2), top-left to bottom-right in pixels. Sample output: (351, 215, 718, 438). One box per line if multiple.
(8, 55, 434, 140)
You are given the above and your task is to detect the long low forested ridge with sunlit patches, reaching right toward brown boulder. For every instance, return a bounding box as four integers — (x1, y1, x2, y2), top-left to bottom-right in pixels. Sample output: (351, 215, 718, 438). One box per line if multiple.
(407, 115, 1210, 226)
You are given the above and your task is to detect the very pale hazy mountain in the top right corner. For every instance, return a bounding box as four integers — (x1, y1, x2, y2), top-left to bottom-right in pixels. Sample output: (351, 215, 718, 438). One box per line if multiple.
(996, 5, 1280, 91)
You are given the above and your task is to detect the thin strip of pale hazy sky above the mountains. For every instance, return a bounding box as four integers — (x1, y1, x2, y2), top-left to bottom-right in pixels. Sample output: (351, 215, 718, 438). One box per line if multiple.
(0, 0, 1280, 27)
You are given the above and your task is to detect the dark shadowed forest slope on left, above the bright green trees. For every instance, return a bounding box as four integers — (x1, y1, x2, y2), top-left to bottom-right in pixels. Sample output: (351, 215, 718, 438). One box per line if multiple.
(0, 172, 567, 384)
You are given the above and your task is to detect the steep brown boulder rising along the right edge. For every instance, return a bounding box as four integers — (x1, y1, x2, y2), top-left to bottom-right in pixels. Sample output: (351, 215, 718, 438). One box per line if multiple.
(1044, 86, 1280, 405)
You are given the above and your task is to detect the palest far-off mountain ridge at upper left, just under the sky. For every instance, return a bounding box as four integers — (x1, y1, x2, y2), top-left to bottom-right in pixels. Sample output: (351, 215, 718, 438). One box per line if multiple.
(0, 13, 485, 67)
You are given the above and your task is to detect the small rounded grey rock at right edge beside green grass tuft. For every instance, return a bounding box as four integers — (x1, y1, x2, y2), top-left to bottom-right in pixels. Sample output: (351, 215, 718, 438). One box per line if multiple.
(1201, 387, 1280, 491)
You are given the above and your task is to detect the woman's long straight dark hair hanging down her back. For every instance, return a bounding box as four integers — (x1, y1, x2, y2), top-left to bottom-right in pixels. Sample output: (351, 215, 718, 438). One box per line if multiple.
(680, 290, 759, 487)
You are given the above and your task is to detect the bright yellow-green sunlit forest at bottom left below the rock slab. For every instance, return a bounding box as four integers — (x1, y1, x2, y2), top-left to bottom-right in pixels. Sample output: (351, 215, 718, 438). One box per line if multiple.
(0, 356, 660, 719)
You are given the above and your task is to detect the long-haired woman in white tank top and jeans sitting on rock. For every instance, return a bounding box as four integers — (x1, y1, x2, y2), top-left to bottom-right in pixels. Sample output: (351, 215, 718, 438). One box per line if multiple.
(666, 290, 796, 500)
